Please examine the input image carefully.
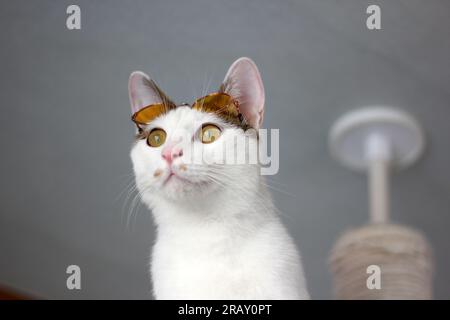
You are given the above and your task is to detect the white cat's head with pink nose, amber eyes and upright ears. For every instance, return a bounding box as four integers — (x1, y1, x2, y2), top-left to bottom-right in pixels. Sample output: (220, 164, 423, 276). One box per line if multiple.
(129, 58, 264, 201)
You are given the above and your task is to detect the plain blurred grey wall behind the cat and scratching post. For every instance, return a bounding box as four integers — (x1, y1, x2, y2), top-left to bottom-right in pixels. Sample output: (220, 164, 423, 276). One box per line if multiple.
(0, 0, 450, 299)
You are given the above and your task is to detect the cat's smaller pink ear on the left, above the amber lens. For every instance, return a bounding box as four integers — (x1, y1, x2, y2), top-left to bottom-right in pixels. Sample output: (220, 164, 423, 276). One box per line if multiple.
(128, 71, 175, 113)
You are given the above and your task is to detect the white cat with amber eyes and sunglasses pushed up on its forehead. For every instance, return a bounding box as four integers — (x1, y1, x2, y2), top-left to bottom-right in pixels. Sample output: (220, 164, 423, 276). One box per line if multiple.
(129, 57, 309, 299)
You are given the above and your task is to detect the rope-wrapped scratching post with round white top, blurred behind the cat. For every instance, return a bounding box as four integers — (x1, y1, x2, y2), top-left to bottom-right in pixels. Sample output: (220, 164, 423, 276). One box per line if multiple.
(329, 107, 432, 299)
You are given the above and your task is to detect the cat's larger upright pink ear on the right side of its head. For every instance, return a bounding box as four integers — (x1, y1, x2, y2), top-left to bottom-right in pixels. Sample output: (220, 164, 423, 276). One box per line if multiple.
(221, 57, 265, 129)
